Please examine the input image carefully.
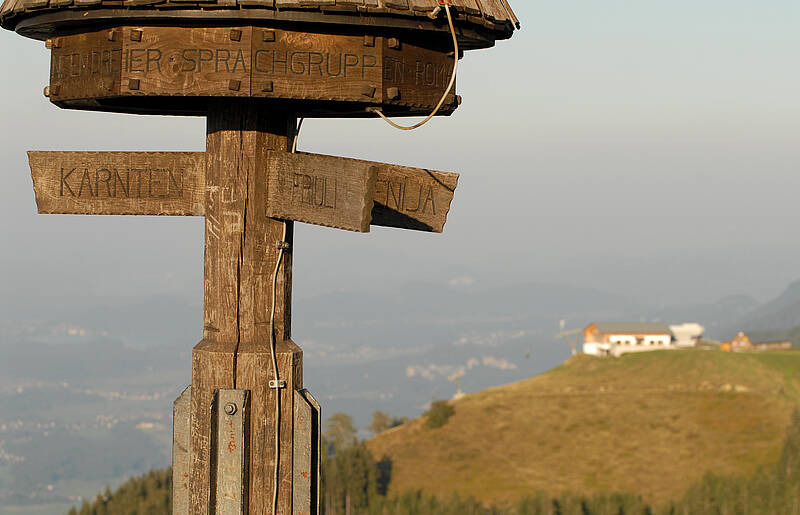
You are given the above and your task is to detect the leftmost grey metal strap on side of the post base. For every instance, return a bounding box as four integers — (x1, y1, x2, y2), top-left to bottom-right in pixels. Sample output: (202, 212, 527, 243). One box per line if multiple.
(172, 386, 192, 515)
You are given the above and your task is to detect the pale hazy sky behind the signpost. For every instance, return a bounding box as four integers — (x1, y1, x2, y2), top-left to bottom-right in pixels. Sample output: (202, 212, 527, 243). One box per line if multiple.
(0, 0, 800, 316)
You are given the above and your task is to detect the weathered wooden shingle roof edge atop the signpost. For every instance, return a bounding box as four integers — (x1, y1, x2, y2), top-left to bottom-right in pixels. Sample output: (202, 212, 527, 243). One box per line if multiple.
(0, 0, 519, 49)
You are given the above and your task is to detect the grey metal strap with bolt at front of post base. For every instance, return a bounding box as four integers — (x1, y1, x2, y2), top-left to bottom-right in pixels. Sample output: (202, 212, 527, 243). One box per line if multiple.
(211, 390, 250, 515)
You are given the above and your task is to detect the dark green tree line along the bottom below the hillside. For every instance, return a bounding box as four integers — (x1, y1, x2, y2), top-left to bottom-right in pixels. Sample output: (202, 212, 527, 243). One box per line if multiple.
(68, 404, 800, 515)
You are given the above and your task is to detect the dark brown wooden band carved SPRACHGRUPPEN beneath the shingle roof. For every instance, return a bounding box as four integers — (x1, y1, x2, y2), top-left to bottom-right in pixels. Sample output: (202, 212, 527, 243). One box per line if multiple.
(47, 26, 457, 116)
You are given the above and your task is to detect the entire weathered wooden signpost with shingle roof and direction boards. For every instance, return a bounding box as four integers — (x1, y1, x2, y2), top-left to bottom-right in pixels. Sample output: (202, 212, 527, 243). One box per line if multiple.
(0, 0, 517, 515)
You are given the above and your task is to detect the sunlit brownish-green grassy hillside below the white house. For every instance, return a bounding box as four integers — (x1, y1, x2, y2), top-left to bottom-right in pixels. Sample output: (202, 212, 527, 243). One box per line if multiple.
(368, 350, 800, 504)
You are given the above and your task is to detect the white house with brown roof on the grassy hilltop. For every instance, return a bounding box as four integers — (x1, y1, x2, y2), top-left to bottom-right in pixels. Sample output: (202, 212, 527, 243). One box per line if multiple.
(583, 322, 676, 357)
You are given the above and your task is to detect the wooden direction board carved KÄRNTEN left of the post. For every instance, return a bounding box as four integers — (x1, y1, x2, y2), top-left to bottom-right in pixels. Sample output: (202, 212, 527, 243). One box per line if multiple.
(28, 151, 206, 216)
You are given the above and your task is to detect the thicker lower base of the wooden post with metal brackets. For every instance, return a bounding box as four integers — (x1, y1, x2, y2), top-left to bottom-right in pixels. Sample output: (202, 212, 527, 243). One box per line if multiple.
(182, 341, 310, 515)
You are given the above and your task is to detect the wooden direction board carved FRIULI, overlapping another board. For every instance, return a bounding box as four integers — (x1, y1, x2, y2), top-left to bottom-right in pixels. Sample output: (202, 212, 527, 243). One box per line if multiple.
(266, 152, 378, 232)
